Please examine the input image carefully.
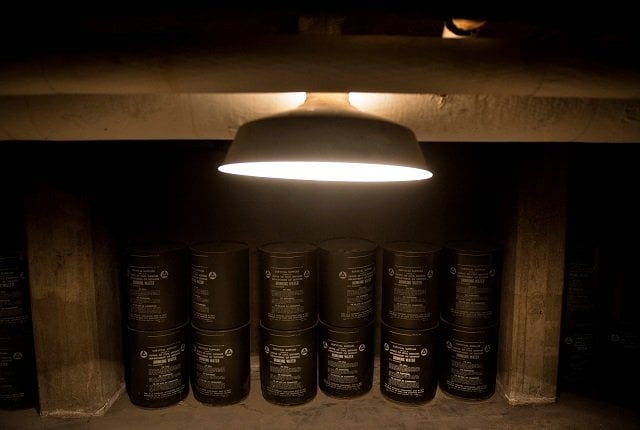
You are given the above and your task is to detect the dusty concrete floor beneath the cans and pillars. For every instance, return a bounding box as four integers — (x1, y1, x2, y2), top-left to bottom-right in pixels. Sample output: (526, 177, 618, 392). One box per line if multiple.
(0, 362, 640, 430)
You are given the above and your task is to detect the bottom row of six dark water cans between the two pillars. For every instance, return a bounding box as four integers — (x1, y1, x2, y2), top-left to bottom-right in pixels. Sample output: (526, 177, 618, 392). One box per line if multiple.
(127, 320, 497, 408)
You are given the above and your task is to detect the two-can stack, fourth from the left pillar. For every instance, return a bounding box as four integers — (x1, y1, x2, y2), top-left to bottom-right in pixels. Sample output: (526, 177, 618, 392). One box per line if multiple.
(318, 238, 378, 398)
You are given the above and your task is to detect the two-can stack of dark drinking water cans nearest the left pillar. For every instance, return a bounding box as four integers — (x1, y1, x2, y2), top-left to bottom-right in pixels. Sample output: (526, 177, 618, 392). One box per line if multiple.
(125, 243, 189, 408)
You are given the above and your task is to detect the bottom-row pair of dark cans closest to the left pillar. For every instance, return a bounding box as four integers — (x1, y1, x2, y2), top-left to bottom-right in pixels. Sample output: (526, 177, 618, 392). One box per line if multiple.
(125, 323, 251, 408)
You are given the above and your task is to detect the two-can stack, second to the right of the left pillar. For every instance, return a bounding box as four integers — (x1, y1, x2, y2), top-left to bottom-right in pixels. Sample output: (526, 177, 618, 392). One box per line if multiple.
(189, 241, 251, 406)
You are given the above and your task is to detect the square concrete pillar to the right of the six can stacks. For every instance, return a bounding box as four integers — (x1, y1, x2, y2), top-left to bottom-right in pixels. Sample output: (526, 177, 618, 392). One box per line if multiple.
(498, 145, 567, 405)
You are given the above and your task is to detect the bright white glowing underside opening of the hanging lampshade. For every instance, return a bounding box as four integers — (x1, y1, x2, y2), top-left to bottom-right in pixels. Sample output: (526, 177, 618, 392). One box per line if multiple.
(218, 161, 433, 182)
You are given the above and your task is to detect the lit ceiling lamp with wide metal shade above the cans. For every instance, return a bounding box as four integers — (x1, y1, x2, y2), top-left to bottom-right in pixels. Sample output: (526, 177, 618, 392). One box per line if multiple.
(218, 93, 433, 182)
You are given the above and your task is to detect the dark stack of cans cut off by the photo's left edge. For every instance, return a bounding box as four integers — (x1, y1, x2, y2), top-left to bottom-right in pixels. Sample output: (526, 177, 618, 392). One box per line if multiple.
(0, 251, 37, 409)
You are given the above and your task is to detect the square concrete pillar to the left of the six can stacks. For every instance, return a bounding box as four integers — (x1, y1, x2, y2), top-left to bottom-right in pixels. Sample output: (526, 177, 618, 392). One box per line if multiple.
(25, 185, 124, 417)
